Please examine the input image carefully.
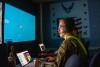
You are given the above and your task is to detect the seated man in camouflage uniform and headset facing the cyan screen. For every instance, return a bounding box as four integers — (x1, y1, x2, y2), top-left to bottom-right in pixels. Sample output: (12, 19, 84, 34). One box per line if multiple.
(46, 18, 88, 67)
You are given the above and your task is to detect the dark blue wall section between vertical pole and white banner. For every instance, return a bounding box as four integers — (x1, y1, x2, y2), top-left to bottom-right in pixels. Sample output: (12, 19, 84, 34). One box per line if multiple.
(43, 3, 63, 47)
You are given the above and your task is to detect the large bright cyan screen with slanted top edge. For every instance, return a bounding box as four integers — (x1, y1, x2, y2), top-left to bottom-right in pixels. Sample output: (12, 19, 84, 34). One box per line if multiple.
(4, 3, 36, 43)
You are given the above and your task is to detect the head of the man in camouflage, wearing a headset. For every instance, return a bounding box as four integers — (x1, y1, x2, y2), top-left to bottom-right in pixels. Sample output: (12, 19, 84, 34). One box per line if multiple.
(58, 18, 75, 38)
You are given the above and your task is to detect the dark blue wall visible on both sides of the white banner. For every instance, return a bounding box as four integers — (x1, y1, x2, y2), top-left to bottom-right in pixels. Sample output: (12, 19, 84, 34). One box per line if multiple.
(43, 0, 100, 48)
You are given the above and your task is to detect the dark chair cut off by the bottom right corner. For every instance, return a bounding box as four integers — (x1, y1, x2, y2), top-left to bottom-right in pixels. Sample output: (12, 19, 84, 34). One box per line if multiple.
(89, 49, 100, 67)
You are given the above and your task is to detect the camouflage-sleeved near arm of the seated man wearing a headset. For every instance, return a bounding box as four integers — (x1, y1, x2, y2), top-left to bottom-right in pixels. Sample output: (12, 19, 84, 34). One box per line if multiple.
(54, 41, 71, 67)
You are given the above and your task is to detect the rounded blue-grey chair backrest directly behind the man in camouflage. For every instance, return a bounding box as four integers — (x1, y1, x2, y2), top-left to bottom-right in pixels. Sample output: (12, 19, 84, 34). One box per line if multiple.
(65, 55, 84, 67)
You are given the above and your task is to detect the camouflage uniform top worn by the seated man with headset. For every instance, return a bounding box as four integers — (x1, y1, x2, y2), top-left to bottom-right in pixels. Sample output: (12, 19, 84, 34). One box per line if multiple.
(54, 38, 86, 67)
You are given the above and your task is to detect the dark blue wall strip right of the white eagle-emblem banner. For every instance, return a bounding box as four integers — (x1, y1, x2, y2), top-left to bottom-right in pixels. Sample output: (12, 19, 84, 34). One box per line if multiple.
(88, 0, 100, 47)
